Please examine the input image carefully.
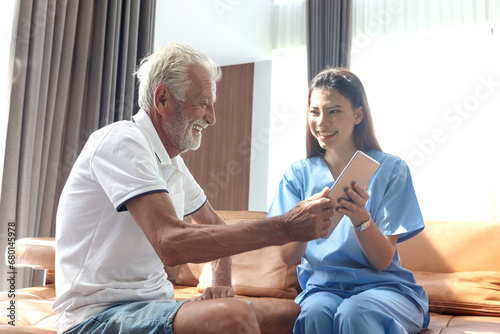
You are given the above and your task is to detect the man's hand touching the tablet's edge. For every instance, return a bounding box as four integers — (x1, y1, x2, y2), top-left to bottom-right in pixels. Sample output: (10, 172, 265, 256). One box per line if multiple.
(280, 187, 336, 241)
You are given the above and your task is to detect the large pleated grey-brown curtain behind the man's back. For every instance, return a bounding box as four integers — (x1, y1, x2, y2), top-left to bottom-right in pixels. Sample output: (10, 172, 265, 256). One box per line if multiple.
(0, 0, 155, 290)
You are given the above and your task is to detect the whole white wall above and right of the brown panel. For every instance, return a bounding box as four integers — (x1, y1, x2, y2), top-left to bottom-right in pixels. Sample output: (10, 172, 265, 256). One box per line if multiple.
(154, 0, 274, 211)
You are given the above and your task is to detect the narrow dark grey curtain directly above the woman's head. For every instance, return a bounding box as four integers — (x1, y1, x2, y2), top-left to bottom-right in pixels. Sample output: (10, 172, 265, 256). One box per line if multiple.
(307, 0, 352, 80)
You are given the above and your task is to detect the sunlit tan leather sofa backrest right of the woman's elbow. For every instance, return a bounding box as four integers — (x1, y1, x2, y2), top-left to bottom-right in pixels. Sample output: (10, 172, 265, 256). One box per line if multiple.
(398, 221, 500, 273)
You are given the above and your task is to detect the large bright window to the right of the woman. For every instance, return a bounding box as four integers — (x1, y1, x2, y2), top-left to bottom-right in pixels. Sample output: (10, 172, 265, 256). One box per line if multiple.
(351, 0, 500, 222)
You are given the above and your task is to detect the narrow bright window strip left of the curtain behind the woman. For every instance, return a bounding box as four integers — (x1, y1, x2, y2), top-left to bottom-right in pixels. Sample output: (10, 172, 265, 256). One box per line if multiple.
(262, 0, 307, 210)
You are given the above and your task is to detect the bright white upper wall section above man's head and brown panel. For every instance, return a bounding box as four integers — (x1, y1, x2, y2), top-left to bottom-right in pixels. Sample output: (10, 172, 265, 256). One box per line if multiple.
(154, 0, 273, 66)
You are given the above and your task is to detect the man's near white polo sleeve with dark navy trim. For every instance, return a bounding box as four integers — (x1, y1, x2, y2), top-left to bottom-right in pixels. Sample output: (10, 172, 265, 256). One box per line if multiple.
(91, 124, 167, 211)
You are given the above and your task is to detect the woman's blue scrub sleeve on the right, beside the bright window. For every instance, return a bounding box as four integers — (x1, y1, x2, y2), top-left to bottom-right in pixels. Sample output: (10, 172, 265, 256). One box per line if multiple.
(370, 159, 424, 242)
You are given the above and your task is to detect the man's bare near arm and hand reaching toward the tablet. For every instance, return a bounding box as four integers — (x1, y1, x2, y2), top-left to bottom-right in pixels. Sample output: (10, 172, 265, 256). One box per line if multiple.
(127, 188, 333, 266)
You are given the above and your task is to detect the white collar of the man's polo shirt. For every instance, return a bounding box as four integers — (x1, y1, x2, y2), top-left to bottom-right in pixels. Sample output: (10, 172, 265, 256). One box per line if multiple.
(132, 109, 182, 179)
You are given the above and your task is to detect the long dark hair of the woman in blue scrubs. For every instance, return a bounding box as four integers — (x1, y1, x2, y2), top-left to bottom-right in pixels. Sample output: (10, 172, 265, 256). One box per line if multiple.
(306, 67, 382, 158)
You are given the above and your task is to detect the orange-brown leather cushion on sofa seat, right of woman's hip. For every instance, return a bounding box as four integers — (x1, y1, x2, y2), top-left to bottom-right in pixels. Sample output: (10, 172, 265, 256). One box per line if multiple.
(414, 271, 500, 316)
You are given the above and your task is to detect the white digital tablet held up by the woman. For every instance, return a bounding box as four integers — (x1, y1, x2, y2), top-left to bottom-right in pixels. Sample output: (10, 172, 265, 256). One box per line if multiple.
(325, 151, 380, 238)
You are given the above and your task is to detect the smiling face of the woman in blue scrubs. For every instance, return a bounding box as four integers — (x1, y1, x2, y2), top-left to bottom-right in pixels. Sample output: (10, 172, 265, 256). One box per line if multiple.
(307, 89, 363, 150)
